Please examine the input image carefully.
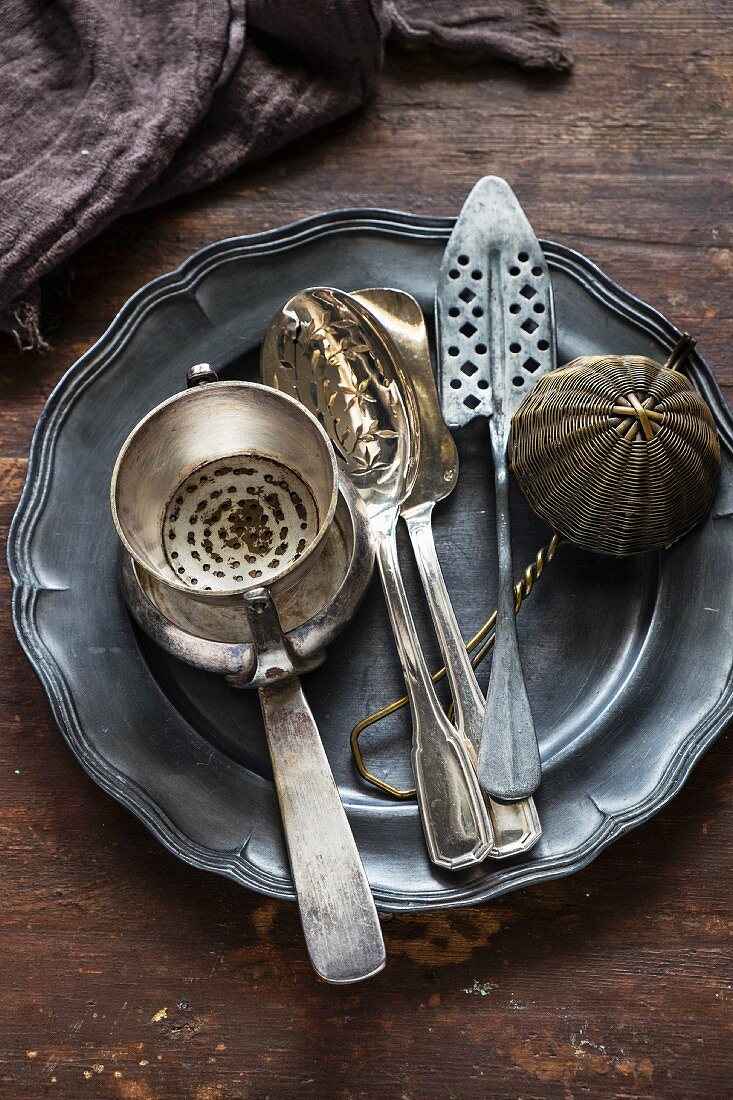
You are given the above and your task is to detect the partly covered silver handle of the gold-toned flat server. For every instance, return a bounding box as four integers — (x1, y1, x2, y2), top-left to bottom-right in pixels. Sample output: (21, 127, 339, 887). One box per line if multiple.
(402, 502, 541, 859)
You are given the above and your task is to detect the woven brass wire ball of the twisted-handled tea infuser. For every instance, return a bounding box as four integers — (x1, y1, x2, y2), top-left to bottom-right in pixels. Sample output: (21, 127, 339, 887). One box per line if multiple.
(512, 337, 721, 557)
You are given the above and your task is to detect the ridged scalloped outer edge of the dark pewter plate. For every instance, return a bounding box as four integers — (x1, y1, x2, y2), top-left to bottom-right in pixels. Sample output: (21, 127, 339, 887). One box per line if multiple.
(8, 209, 733, 912)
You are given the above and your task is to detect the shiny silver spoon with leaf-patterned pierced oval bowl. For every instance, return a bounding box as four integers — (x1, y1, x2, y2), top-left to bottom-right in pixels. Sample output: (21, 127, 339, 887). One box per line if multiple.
(262, 288, 492, 869)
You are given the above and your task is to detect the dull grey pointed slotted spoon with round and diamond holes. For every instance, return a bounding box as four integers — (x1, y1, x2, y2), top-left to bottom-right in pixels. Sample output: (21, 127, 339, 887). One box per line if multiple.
(436, 176, 556, 801)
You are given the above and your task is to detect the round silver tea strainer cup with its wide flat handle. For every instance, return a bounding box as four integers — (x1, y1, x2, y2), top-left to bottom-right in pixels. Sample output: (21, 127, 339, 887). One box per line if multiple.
(111, 366, 385, 983)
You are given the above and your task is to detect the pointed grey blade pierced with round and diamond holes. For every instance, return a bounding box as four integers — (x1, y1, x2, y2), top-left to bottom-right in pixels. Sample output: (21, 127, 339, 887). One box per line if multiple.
(436, 176, 556, 428)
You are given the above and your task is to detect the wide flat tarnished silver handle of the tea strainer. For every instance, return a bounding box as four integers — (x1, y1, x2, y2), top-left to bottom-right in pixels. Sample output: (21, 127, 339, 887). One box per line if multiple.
(244, 589, 385, 985)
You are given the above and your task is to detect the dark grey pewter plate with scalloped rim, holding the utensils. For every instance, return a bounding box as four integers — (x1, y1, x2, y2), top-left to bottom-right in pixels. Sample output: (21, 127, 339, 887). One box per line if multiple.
(9, 210, 733, 911)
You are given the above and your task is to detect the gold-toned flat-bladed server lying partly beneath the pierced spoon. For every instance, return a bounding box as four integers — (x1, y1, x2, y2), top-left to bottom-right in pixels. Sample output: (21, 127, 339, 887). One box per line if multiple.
(350, 289, 541, 859)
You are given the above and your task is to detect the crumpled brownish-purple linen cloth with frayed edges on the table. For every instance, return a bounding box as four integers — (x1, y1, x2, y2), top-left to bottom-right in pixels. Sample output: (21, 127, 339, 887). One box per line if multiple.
(0, 0, 571, 347)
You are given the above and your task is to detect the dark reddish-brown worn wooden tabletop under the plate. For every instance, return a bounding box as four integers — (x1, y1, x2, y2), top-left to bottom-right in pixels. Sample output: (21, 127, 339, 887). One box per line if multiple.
(0, 0, 733, 1100)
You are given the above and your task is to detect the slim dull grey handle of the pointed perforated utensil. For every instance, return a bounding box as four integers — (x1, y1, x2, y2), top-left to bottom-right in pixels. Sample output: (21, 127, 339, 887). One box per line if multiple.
(479, 429, 541, 802)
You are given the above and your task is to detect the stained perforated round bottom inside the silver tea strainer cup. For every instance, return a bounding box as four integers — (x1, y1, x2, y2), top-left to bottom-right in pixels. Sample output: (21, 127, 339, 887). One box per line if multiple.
(163, 454, 319, 592)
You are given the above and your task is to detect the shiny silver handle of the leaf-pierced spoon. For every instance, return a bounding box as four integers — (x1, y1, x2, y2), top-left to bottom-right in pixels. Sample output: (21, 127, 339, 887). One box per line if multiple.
(374, 515, 493, 870)
